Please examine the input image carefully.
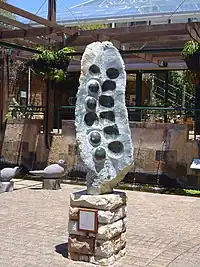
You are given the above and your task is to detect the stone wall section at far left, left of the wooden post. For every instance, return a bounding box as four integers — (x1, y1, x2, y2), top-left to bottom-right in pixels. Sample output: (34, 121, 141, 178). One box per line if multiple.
(1, 120, 48, 168)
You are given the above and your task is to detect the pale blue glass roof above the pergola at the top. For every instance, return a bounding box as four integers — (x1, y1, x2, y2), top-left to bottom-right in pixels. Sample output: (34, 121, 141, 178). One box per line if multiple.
(52, 0, 200, 22)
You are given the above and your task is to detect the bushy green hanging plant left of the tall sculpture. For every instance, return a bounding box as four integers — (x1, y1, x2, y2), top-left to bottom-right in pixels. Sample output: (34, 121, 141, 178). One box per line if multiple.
(27, 47, 75, 82)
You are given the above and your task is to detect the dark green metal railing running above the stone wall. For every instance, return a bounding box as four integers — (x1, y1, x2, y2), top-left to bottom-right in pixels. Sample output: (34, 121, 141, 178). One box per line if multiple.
(8, 106, 200, 139)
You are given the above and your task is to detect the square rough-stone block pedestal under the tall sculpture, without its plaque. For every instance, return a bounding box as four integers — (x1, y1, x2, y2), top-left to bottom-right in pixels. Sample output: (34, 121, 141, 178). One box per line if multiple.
(68, 191, 127, 266)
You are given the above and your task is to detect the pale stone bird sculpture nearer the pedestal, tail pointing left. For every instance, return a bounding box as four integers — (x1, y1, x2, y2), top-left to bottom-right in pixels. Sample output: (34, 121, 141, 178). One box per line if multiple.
(30, 159, 66, 179)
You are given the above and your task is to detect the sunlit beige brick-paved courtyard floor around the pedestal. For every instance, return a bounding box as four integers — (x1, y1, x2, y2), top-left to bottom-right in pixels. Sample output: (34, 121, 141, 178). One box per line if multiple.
(0, 180, 200, 267)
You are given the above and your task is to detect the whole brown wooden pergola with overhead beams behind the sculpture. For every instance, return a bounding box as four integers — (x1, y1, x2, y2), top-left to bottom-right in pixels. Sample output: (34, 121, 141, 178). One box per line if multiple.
(0, 0, 200, 147)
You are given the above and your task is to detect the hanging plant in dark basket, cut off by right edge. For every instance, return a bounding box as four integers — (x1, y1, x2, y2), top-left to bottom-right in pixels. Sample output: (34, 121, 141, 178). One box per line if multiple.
(182, 40, 200, 72)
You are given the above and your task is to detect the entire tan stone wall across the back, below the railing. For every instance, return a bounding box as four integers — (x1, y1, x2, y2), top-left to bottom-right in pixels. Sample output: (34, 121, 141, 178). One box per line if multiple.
(2, 120, 200, 186)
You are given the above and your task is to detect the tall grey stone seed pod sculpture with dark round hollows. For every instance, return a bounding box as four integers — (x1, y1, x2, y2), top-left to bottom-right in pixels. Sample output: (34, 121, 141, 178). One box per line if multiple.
(75, 42, 133, 195)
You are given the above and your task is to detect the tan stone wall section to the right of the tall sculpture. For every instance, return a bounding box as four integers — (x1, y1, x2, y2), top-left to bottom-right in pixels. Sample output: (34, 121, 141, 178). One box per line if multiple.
(130, 122, 199, 184)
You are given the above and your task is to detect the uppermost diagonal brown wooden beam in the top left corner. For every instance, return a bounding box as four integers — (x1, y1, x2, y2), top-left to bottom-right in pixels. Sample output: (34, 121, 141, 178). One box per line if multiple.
(0, 1, 58, 28)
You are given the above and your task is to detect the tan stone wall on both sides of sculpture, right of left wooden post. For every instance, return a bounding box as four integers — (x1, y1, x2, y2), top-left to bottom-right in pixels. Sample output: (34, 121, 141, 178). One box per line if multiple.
(49, 121, 200, 185)
